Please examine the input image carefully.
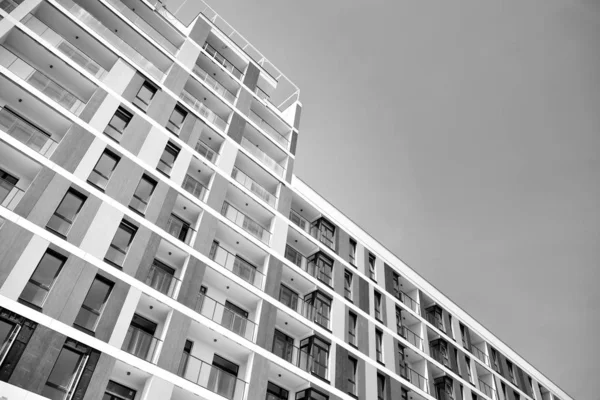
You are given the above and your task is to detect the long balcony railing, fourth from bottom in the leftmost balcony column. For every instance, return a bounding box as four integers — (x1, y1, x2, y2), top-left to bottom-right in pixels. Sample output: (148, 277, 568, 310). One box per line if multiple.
(23, 14, 106, 79)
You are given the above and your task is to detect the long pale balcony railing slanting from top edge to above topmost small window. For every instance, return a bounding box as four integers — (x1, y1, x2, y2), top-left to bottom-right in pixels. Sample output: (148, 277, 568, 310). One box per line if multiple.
(56, 0, 165, 81)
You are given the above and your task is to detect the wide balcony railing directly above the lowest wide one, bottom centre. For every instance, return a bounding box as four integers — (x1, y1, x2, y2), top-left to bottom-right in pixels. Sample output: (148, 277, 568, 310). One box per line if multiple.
(195, 293, 256, 342)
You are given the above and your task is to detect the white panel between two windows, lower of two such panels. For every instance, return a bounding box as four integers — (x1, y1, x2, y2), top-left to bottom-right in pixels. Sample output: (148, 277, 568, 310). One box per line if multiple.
(79, 203, 123, 260)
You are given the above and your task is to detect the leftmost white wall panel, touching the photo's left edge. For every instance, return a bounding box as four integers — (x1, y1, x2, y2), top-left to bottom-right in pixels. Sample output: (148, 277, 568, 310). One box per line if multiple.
(0, 235, 50, 300)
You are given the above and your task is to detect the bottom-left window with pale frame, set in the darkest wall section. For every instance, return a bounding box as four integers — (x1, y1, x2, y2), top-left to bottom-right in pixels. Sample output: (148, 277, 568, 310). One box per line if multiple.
(42, 339, 89, 400)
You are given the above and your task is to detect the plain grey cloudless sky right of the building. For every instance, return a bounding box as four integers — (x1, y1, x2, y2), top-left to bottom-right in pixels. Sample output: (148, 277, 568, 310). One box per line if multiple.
(209, 0, 600, 400)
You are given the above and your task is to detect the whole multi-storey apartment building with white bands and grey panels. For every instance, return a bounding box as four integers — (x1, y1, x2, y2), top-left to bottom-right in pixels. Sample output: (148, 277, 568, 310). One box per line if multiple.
(0, 0, 570, 400)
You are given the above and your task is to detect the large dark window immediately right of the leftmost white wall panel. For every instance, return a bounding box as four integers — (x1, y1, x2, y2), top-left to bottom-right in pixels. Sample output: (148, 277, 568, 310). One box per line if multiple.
(19, 249, 67, 307)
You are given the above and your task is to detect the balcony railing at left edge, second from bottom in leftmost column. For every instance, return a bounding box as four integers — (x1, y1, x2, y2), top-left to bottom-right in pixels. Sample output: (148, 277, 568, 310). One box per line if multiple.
(0, 108, 58, 158)
